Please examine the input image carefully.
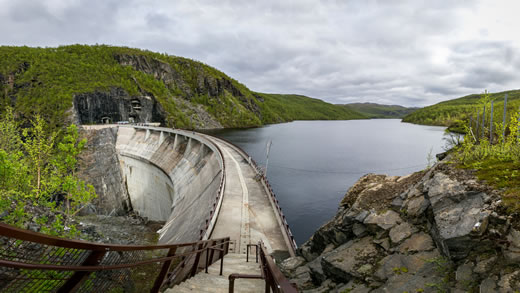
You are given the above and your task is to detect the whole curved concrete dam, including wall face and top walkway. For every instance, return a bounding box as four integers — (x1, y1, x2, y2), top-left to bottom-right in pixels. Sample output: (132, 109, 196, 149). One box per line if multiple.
(85, 125, 296, 256)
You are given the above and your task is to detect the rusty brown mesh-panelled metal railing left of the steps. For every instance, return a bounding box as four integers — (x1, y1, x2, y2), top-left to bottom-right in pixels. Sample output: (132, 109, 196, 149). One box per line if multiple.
(0, 223, 229, 292)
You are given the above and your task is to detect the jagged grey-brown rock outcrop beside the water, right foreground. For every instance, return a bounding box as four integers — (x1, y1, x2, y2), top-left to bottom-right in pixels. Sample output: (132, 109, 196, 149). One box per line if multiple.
(281, 162, 520, 293)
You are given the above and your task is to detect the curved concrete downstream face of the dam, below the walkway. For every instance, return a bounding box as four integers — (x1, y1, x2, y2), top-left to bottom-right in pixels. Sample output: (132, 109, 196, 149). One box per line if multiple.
(116, 126, 224, 243)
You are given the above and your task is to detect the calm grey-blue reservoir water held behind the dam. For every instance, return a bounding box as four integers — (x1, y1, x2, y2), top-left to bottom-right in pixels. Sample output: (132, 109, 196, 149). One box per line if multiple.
(206, 119, 444, 245)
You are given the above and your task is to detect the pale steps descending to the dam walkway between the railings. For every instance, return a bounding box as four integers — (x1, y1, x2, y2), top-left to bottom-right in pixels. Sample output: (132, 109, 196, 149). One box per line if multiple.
(164, 253, 265, 293)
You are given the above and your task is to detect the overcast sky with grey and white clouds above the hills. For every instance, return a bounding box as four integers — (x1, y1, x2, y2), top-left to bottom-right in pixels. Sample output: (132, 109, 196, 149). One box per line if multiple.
(0, 0, 520, 106)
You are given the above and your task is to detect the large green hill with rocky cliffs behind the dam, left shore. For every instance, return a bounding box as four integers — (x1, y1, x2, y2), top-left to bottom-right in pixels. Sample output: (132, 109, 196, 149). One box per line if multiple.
(0, 45, 366, 128)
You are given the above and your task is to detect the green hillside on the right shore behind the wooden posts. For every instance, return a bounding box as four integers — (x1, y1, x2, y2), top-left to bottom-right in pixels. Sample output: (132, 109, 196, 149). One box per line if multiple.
(403, 90, 520, 132)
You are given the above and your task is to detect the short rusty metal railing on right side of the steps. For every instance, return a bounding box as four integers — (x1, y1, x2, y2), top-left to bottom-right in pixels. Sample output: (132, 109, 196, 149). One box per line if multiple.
(228, 241, 298, 293)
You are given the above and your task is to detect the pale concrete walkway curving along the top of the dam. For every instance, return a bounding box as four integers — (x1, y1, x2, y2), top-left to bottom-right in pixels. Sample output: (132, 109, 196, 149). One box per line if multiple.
(204, 135, 290, 253)
